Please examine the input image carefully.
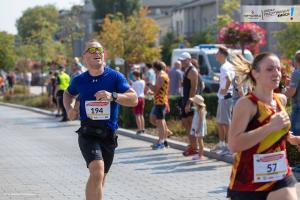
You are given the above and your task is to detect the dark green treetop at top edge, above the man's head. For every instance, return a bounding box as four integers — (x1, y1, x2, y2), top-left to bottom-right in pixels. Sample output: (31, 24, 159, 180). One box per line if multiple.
(93, 0, 141, 31)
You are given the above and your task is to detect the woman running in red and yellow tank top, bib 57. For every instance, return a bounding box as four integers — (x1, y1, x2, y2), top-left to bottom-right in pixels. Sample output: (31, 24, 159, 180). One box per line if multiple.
(228, 53, 297, 200)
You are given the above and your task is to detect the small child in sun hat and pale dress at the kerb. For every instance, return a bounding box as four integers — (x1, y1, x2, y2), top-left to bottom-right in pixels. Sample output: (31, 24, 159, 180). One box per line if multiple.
(190, 95, 207, 160)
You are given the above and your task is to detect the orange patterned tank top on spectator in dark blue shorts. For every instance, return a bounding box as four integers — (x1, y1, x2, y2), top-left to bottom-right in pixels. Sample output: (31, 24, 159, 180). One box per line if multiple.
(154, 71, 169, 105)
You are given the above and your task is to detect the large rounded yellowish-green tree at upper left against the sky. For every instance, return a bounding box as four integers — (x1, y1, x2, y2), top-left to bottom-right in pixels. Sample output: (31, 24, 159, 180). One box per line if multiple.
(17, 5, 63, 63)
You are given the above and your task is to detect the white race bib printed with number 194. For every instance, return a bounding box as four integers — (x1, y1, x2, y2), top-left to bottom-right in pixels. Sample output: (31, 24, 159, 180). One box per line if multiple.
(85, 101, 110, 120)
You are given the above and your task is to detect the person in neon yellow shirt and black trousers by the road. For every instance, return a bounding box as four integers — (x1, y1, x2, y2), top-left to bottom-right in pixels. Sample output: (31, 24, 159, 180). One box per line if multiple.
(56, 66, 70, 122)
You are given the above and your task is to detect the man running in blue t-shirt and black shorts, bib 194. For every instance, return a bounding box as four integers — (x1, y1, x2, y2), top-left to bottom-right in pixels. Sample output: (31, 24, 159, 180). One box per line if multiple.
(64, 40, 138, 200)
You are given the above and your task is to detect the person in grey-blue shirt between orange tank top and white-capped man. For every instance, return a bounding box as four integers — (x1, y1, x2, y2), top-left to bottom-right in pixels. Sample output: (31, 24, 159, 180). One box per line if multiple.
(168, 61, 183, 96)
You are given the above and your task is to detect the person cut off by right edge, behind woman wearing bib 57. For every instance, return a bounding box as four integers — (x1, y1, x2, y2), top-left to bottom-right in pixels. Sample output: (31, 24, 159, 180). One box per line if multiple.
(284, 50, 300, 136)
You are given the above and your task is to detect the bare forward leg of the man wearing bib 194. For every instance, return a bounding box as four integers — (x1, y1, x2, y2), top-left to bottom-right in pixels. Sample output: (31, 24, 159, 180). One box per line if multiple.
(86, 160, 105, 200)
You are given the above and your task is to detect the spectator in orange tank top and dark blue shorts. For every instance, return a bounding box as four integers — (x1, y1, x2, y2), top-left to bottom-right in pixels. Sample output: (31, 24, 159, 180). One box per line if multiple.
(147, 61, 169, 150)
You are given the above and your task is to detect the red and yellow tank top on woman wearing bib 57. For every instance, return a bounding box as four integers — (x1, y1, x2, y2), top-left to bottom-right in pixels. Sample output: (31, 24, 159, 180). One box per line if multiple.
(228, 93, 291, 192)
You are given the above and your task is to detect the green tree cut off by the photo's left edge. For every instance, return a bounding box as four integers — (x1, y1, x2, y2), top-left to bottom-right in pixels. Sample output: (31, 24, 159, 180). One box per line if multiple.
(0, 32, 15, 70)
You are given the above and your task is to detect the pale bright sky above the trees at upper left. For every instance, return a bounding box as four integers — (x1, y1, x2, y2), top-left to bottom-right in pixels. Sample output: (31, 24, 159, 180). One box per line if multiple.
(0, 0, 84, 34)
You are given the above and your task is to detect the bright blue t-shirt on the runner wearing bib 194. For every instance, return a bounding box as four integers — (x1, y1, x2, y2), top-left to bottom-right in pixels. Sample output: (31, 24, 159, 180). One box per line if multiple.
(67, 67, 130, 130)
